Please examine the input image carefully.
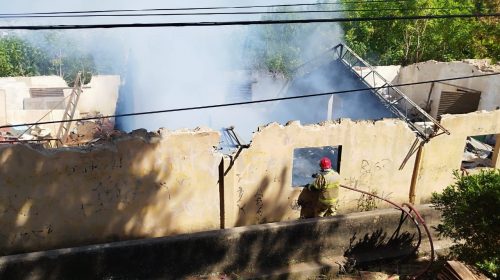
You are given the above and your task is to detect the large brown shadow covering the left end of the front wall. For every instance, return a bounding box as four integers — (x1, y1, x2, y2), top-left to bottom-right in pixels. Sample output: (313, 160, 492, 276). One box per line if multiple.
(0, 136, 182, 255)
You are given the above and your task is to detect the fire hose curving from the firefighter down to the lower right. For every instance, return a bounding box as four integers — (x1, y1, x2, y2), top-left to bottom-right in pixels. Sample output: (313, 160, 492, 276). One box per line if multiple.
(340, 185, 434, 279)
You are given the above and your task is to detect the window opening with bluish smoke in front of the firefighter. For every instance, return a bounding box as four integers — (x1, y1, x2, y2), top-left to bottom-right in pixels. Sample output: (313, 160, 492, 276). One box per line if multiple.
(292, 146, 342, 187)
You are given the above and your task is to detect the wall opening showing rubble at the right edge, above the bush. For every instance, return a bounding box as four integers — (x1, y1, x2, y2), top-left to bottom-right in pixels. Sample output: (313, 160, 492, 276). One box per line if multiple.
(461, 134, 499, 169)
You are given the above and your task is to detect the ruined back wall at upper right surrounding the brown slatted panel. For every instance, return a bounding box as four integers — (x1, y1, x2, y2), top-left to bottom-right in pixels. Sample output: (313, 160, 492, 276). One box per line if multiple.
(394, 61, 500, 117)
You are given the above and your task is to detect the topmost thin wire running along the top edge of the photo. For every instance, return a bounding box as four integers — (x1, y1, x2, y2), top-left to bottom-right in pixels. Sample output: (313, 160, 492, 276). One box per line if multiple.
(0, 0, 410, 16)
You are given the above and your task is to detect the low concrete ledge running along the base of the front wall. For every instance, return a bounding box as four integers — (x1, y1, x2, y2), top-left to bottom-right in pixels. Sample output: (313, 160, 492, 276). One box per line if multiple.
(0, 205, 440, 279)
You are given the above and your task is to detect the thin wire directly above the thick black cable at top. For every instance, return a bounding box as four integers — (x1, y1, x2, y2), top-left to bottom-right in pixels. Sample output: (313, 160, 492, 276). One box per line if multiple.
(0, 7, 460, 19)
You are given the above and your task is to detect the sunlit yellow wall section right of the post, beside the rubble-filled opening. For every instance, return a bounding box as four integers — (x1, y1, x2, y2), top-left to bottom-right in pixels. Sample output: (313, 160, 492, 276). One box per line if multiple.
(416, 110, 500, 203)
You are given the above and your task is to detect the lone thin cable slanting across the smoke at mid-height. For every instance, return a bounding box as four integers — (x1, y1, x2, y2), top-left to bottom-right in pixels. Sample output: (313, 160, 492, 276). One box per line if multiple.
(0, 73, 500, 128)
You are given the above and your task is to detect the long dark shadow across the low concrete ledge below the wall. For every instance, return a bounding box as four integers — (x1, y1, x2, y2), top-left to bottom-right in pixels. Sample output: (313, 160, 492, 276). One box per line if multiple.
(0, 217, 344, 279)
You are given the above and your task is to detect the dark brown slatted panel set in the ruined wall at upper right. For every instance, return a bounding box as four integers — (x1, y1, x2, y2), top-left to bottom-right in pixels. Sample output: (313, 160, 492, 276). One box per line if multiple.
(437, 91, 481, 116)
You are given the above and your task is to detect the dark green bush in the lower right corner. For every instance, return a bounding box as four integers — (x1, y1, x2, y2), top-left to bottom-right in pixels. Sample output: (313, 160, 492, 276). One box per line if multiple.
(431, 169, 500, 277)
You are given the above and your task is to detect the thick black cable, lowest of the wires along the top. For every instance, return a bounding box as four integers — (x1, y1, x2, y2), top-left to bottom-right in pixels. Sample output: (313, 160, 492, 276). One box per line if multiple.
(0, 13, 500, 30)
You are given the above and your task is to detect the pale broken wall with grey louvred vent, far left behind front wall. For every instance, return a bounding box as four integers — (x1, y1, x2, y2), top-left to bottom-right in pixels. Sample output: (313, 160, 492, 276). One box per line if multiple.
(0, 76, 120, 147)
